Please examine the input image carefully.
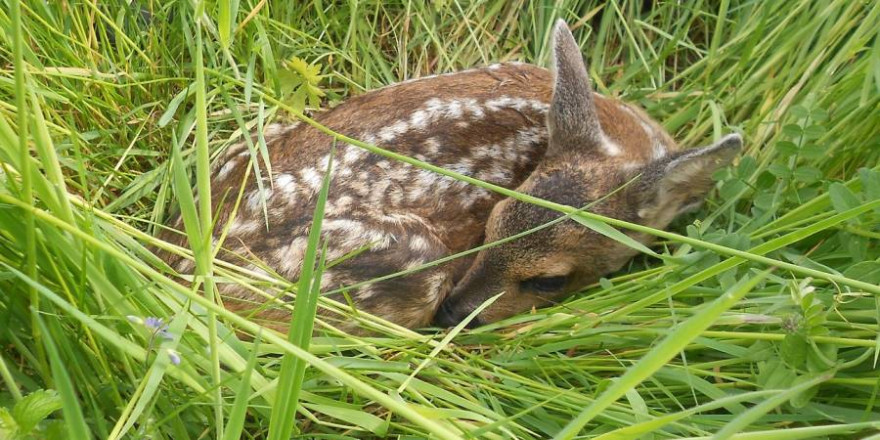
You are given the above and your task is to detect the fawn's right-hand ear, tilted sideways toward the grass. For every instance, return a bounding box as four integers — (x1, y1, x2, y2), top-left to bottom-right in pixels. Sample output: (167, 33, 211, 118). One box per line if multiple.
(638, 134, 742, 222)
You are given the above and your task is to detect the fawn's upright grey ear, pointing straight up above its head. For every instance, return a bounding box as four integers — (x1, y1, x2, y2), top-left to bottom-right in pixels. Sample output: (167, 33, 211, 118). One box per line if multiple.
(547, 20, 604, 156)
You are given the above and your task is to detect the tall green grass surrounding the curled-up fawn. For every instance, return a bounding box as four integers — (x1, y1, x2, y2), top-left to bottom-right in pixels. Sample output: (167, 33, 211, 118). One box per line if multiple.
(0, 0, 880, 440)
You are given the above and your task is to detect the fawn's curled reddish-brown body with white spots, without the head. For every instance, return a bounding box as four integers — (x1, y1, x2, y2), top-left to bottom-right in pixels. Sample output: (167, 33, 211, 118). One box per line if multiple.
(162, 21, 740, 328)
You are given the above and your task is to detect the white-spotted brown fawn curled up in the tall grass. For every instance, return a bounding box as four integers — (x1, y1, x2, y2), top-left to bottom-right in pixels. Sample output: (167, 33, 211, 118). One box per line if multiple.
(162, 20, 742, 328)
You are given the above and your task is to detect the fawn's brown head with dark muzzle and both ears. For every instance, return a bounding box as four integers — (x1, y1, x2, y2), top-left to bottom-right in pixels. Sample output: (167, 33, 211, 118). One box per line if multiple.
(435, 20, 742, 325)
